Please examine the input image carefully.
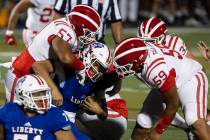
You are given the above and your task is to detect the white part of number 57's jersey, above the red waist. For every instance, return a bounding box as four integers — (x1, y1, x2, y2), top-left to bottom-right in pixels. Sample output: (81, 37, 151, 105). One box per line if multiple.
(28, 18, 77, 61)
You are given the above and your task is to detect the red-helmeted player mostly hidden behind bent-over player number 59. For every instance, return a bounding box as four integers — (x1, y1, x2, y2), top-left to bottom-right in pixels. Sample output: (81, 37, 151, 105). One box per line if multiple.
(137, 17, 202, 140)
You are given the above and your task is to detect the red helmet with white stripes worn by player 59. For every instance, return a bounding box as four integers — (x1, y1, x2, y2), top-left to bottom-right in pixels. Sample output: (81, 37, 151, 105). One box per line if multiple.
(113, 38, 148, 77)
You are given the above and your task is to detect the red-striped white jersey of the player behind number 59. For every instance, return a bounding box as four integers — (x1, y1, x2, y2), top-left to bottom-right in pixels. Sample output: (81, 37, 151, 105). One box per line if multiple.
(163, 35, 187, 56)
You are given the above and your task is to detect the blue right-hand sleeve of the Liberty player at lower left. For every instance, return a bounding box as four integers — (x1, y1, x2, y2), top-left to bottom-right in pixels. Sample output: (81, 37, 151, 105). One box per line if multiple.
(49, 107, 71, 133)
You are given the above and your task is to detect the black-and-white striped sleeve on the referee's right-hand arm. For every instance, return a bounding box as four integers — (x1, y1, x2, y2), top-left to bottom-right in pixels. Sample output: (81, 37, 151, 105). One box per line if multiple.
(108, 0, 122, 22)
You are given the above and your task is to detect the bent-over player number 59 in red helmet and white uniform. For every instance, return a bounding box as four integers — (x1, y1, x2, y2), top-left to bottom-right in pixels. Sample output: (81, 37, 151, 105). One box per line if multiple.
(114, 38, 209, 140)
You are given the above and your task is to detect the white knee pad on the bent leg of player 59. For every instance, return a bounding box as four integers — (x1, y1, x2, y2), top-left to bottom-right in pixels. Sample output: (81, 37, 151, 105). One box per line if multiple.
(137, 113, 152, 128)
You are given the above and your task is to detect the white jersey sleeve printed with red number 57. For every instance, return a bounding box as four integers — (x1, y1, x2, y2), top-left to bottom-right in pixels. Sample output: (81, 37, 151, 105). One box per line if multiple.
(54, 20, 77, 46)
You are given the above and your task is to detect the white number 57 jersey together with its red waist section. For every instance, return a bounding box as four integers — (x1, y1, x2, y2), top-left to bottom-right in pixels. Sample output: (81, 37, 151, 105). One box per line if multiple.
(12, 18, 77, 75)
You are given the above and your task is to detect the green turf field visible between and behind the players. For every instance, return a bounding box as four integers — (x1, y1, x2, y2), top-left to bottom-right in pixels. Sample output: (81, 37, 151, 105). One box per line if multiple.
(0, 28, 210, 140)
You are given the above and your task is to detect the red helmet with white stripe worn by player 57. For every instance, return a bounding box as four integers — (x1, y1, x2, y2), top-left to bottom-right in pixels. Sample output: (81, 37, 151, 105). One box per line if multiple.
(68, 4, 100, 44)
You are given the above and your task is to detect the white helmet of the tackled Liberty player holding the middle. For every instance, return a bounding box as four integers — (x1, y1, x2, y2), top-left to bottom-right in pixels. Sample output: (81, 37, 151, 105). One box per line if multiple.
(83, 42, 112, 82)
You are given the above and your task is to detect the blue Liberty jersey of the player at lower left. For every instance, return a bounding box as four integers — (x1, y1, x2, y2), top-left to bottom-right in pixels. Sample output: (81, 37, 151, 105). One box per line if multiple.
(0, 103, 71, 140)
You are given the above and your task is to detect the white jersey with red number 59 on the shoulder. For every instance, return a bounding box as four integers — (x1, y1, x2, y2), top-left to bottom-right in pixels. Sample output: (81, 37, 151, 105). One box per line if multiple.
(136, 43, 202, 89)
